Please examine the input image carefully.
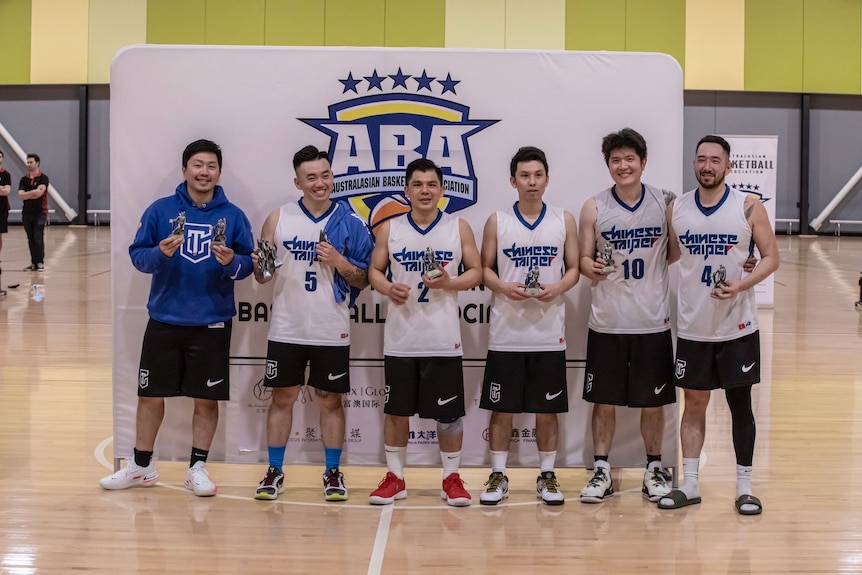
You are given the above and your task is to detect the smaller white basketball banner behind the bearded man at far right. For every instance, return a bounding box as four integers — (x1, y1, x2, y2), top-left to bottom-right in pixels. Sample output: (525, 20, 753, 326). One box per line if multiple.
(722, 136, 778, 307)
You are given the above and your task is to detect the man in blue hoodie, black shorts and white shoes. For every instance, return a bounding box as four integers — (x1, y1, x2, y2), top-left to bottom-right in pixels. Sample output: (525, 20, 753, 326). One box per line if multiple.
(99, 140, 254, 497)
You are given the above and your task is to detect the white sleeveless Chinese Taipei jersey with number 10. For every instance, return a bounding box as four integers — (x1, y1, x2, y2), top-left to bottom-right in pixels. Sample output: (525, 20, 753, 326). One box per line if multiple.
(589, 184, 670, 334)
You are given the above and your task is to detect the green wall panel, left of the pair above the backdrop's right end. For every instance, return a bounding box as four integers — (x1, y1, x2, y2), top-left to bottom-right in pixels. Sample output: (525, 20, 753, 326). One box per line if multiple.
(566, 0, 626, 51)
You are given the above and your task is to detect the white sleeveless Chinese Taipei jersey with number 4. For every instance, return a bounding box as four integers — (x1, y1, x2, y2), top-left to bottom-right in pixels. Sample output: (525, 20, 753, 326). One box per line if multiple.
(672, 186, 758, 341)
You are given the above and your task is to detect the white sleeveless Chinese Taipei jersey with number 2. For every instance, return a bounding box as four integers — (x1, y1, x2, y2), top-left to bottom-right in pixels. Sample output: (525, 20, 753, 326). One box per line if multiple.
(383, 212, 463, 357)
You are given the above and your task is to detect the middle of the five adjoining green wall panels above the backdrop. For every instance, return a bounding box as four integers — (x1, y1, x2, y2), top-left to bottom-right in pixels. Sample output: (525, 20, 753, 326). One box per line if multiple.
(264, 0, 326, 46)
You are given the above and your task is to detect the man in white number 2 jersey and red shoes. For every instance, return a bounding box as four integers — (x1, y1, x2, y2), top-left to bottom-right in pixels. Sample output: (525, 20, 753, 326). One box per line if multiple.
(368, 158, 482, 507)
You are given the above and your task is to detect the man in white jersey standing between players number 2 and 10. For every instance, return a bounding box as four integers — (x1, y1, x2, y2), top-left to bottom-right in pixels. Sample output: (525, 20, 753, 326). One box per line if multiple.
(479, 146, 580, 505)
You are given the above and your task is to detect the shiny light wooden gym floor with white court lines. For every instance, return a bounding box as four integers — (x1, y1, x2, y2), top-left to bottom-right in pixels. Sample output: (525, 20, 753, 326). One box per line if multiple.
(0, 226, 862, 575)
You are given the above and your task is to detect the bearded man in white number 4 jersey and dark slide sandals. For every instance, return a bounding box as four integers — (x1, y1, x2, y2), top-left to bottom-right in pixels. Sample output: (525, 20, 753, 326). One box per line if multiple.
(658, 136, 779, 515)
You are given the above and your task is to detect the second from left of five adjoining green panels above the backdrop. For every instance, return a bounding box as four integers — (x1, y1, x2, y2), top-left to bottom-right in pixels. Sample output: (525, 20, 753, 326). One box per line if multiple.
(204, 0, 266, 46)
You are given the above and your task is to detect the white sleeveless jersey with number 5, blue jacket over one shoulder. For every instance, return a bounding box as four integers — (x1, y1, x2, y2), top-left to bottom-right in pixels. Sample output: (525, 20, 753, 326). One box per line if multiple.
(268, 202, 350, 345)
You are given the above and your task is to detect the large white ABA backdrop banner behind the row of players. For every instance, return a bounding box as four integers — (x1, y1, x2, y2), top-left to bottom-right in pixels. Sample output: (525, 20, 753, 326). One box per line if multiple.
(111, 46, 683, 466)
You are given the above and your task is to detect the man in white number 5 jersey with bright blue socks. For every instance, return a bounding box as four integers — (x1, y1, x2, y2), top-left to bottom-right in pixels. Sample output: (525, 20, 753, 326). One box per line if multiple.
(254, 146, 374, 501)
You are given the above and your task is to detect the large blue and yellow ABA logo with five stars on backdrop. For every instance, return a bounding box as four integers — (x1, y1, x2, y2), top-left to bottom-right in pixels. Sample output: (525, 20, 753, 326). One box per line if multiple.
(300, 68, 499, 234)
